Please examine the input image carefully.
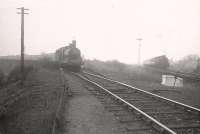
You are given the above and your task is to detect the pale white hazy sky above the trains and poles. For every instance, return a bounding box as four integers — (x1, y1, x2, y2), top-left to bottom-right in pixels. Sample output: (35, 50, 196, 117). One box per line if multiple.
(0, 0, 200, 63)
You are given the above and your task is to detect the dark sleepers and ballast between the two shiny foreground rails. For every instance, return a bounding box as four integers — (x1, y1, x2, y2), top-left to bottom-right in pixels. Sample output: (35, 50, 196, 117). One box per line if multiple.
(77, 73, 200, 134)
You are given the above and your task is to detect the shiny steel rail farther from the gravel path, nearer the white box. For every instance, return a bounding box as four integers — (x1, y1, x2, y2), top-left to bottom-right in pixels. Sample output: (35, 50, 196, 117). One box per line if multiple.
(83, 72, 200, 115)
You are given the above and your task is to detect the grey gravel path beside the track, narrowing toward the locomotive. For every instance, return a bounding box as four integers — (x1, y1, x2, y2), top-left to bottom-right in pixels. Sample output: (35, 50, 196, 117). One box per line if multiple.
(65, 75, 124, 134)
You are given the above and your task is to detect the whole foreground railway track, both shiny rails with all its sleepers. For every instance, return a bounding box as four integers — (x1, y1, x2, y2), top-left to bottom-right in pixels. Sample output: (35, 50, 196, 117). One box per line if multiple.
(76, 72, 200, 134)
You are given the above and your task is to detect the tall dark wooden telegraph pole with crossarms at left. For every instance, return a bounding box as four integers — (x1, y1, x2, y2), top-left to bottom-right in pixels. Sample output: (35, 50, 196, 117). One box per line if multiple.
(17, 7, 29, 84)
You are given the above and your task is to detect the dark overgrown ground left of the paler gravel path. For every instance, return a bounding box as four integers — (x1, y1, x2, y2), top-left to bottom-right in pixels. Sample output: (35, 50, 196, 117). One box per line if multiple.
(0, 67, 63, 134)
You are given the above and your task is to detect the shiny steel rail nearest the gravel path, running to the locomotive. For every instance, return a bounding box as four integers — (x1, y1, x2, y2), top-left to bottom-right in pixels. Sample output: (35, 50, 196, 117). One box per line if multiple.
(73, 73, 177, 134)
